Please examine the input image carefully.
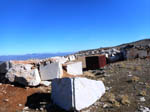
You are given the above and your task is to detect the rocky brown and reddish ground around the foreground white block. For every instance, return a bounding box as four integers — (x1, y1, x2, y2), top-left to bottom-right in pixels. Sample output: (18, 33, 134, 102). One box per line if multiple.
(0, 59, 150, 112)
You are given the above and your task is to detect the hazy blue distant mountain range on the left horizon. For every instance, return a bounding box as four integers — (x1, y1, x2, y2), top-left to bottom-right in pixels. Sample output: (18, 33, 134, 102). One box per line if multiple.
(0, 52, 73, 63)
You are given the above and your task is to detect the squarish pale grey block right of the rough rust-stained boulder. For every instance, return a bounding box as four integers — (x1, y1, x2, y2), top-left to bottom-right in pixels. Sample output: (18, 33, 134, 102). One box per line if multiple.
(40, 62, 63, 81)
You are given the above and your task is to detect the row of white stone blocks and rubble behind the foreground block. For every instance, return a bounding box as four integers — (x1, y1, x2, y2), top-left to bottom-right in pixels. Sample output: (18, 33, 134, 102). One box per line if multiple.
(0, 55, 83, 86)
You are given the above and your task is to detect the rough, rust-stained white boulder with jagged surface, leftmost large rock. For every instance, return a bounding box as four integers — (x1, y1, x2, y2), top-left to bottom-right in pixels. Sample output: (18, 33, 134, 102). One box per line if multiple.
(5, 64, 41, 86)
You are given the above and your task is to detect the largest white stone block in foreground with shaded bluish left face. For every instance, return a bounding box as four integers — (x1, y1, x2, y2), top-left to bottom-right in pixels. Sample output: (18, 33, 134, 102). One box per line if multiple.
(51, 77, 105, 111)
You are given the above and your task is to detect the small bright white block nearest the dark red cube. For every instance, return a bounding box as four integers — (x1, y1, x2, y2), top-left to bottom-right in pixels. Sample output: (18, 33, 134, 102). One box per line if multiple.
(66, 62, 83, 75)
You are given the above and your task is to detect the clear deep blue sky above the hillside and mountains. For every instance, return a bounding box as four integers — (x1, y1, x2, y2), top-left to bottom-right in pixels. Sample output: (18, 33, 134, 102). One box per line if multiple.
(0, 0, 150, 55)
